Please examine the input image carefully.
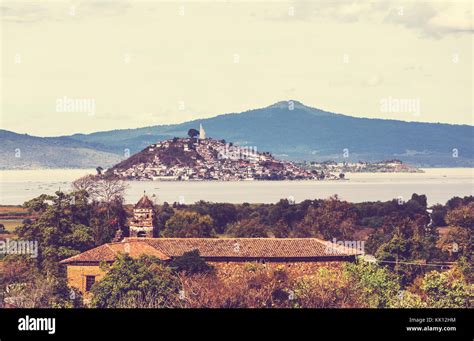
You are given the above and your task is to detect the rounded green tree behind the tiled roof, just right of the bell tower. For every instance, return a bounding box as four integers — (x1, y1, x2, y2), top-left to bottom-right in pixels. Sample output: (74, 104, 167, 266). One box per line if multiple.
(163, 210, 215, 238)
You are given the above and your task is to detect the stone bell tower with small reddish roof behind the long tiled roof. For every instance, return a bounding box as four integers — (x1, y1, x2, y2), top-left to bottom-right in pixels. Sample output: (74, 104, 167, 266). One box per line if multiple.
(130, 194, 156, 238)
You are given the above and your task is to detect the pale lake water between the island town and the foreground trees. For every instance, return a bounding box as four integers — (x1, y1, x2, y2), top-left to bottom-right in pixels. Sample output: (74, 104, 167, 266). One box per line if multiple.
(0, 168, 474, 205)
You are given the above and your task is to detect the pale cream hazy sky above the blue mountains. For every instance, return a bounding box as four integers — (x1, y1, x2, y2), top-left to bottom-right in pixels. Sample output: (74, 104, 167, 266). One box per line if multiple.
(0, 0, 474, 136)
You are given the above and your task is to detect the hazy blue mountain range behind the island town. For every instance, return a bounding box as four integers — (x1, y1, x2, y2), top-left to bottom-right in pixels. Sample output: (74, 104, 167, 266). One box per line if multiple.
(0, 101, 474, 169)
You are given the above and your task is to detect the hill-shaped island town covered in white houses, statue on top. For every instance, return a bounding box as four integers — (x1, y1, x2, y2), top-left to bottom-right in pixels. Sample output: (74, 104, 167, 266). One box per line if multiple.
(106, 126, 328, 181)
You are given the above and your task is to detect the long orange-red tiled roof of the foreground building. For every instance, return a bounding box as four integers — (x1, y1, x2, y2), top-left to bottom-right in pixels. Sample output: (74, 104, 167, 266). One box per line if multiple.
(61, 238, 361, 264)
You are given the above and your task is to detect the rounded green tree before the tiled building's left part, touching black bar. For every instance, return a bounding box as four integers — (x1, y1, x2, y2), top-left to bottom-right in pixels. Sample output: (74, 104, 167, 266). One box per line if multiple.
(91, 254, 180, 308)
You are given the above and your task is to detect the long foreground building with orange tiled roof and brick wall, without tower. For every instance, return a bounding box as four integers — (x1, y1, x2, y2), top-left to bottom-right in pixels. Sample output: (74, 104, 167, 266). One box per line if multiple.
(61, 238, 361, 294)
